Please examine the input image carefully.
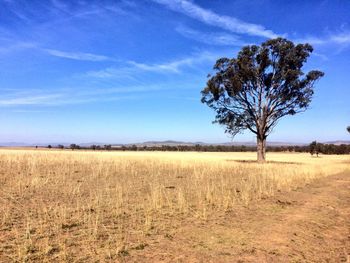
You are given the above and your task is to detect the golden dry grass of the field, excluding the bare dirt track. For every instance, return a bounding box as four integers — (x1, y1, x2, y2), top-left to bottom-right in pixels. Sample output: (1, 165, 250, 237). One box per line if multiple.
(0, 150, 350, 262)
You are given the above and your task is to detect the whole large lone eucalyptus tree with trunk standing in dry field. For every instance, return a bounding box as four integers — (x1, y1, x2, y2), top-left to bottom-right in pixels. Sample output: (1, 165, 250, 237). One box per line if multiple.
(201, 38, 324, 161)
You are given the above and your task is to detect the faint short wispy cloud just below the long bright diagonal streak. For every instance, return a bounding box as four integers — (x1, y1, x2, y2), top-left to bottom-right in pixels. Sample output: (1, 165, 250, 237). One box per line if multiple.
(175, 25, 244, 46)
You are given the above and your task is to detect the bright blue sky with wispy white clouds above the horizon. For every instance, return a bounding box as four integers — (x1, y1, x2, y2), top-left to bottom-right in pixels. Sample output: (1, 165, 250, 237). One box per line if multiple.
(0, 0, 350, 143)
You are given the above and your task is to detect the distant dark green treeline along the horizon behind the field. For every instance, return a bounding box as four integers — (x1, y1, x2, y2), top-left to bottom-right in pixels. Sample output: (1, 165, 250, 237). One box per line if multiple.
(48, 142, 350, 154)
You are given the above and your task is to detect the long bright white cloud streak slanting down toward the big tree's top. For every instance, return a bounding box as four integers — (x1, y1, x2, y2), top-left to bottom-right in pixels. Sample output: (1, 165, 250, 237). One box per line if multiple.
(153, 0, 278, 38)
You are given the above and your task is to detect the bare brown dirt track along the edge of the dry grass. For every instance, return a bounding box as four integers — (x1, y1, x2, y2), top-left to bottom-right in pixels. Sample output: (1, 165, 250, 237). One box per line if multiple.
(131, 174, 350, 262)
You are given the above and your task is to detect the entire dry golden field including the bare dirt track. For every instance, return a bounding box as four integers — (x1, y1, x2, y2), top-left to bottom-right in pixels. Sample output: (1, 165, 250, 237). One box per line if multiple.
(0, 149, 350, 262)
